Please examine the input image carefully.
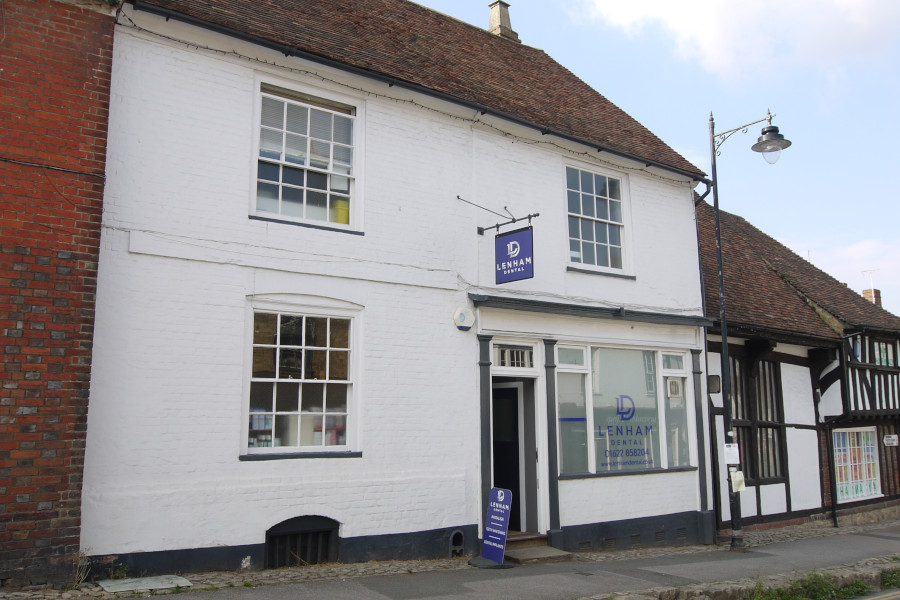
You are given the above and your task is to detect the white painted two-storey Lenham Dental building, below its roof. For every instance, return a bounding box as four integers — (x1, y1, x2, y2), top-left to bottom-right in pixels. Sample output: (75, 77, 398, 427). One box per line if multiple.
(82, 0, 711, 572)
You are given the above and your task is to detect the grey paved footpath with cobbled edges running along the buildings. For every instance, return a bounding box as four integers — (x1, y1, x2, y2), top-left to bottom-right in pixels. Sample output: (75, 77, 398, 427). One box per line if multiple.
(7, 520, 900, 600)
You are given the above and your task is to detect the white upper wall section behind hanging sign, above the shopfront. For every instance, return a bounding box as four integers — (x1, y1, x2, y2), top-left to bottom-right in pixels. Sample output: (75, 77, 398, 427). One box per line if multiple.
(467, 133, 702, 315)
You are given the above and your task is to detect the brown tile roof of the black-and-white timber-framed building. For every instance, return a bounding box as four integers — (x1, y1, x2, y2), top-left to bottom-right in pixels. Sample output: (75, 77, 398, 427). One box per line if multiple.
(697, 202, 900, 339)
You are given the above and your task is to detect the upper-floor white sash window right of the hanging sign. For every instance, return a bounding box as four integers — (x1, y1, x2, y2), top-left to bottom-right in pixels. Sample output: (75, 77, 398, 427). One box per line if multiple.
(566, 166, 625, 269)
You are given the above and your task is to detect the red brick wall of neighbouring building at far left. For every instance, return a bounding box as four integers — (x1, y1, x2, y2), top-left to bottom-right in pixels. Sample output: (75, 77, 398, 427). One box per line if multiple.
(0, 0, 113, 586)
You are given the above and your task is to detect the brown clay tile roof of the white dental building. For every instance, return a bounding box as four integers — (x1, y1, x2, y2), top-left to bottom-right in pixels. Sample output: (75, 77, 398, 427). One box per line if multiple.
(131, 0, 704, 178)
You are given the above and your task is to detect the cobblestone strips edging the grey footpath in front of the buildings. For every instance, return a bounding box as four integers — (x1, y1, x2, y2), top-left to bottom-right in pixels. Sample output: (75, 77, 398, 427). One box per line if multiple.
(7, 520, 900, 600)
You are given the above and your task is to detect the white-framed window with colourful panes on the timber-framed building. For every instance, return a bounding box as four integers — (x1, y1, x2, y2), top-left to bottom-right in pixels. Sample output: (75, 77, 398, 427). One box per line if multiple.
(832, 427, 881, 502)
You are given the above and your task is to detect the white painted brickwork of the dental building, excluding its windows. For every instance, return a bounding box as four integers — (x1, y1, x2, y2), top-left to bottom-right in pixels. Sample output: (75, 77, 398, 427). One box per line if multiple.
(82, 14, 702, 554)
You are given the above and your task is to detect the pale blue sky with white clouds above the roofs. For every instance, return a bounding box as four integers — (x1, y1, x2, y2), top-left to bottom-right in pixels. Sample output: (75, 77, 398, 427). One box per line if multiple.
(418, 0, 900, 315)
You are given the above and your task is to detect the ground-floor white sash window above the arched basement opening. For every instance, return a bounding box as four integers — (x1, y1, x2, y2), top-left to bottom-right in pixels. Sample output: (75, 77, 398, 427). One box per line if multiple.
(247, 311, 353, 452)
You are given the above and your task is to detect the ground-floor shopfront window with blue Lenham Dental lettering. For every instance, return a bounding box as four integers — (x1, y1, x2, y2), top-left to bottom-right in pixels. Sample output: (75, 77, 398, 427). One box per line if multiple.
(557, 346, 692, 475)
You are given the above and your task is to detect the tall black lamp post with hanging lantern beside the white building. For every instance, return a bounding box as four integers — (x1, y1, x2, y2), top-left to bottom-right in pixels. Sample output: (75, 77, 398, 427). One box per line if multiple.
(709, 112, 791, 551)
